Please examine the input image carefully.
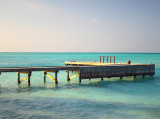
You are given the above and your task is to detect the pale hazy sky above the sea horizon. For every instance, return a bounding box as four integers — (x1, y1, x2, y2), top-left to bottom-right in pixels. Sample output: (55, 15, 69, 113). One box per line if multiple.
(0, 0, 160, 53)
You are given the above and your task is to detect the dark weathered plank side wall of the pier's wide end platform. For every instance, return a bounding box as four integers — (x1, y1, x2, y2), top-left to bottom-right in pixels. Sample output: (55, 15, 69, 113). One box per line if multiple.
(80, 65, 155, 79)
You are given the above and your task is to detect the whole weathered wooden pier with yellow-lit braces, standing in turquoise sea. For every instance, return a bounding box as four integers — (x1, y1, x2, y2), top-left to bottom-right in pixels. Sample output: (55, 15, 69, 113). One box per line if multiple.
(0, 57, 155, 86)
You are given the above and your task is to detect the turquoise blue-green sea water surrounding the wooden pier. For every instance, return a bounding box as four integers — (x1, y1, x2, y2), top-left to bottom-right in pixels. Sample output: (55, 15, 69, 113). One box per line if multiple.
(0, 53, 160, 119)
